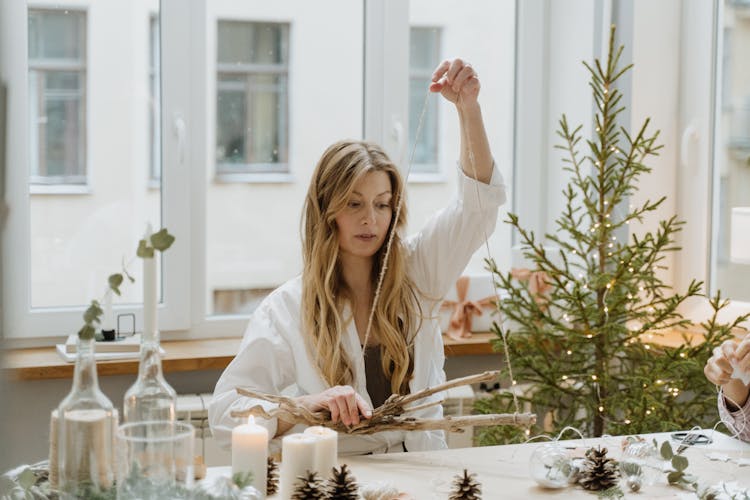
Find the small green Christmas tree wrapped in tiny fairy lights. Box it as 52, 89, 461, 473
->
475, 27, 749, 445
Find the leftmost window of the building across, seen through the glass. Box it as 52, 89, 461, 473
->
28, 9, 86, 184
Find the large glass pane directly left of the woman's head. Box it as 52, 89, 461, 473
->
205, 0, 364, 315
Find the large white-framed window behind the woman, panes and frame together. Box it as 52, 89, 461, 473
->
0, 0, 516, 342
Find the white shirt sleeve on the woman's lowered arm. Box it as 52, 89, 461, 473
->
208, 295, 296, 446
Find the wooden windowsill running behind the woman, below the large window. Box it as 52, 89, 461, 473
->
2, 332, 502, 380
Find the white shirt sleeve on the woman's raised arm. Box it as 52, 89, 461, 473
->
406, 164, 506, 299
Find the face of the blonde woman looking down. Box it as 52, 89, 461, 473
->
336, 171, 393, 258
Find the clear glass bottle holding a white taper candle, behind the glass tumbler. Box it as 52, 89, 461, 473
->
123, 331, 177, 423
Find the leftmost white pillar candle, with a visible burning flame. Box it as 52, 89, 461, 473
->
232, 416, 268, 497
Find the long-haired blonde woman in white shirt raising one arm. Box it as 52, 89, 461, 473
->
209, 59, 505, 454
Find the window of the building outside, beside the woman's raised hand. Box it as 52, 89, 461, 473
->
409, 28, 440, 172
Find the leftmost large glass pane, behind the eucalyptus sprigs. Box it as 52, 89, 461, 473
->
28, 4, 161, 308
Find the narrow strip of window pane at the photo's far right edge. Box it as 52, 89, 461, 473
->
714, 2, 750, 302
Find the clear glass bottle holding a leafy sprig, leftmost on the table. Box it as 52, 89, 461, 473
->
52, 338, 117, 499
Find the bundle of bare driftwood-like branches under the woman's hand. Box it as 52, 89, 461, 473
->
231, 371, 536, 434
